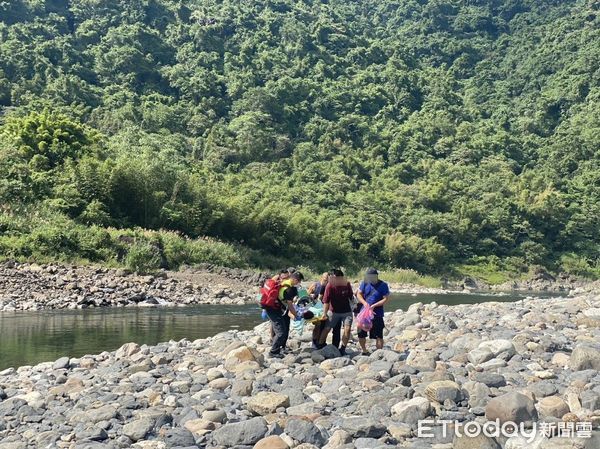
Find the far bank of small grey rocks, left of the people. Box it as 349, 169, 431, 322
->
0, 262, 260, 312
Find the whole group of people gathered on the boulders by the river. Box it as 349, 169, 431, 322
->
263, 268, 390, 358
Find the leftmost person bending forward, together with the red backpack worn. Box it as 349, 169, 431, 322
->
260, 271, 304, 358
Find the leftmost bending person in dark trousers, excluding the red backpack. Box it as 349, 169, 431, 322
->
267, 271, 304, 358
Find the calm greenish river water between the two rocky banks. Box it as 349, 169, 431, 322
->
0, 293, 560, 370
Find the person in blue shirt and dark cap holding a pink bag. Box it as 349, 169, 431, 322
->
356, 268, 390, 355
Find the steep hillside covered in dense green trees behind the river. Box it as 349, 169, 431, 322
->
0, 0, 600, 276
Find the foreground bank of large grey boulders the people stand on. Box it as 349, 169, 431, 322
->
0, 294, 600, 449
